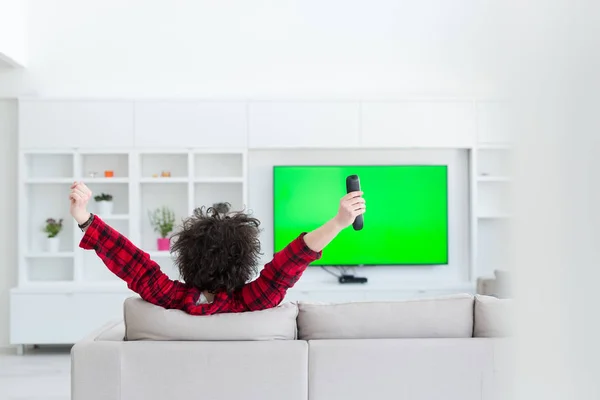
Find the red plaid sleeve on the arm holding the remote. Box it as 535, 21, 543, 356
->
238, 233, 322, 311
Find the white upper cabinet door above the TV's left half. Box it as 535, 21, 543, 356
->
248, 102, 360, 148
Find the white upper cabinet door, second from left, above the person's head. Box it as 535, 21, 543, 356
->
135, 101, 248, 148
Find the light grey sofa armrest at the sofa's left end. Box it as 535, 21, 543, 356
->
71, 321, 123, 400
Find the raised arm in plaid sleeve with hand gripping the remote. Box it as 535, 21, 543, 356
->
238, 192, 366, 311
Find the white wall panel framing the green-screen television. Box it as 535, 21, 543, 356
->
248, 150, 469, 288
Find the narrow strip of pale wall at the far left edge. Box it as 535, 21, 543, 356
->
0, 100, 17, 348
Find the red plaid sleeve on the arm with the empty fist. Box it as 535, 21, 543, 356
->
79, 216, 187, 308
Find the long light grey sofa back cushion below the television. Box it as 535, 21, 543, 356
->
298, 294, 473, 340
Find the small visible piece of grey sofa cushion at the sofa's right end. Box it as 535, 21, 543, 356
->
473, 294, 513, 337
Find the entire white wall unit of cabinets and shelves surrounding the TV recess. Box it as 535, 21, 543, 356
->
10, 98, 513, 350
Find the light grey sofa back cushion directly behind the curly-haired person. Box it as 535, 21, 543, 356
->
124, 297, 298, 341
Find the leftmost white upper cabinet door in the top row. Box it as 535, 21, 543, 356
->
19, 100, 133, 149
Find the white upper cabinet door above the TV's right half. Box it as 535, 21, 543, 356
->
361, 101, 476, 148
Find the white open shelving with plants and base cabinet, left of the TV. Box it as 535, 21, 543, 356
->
11, 148, 248, 345
